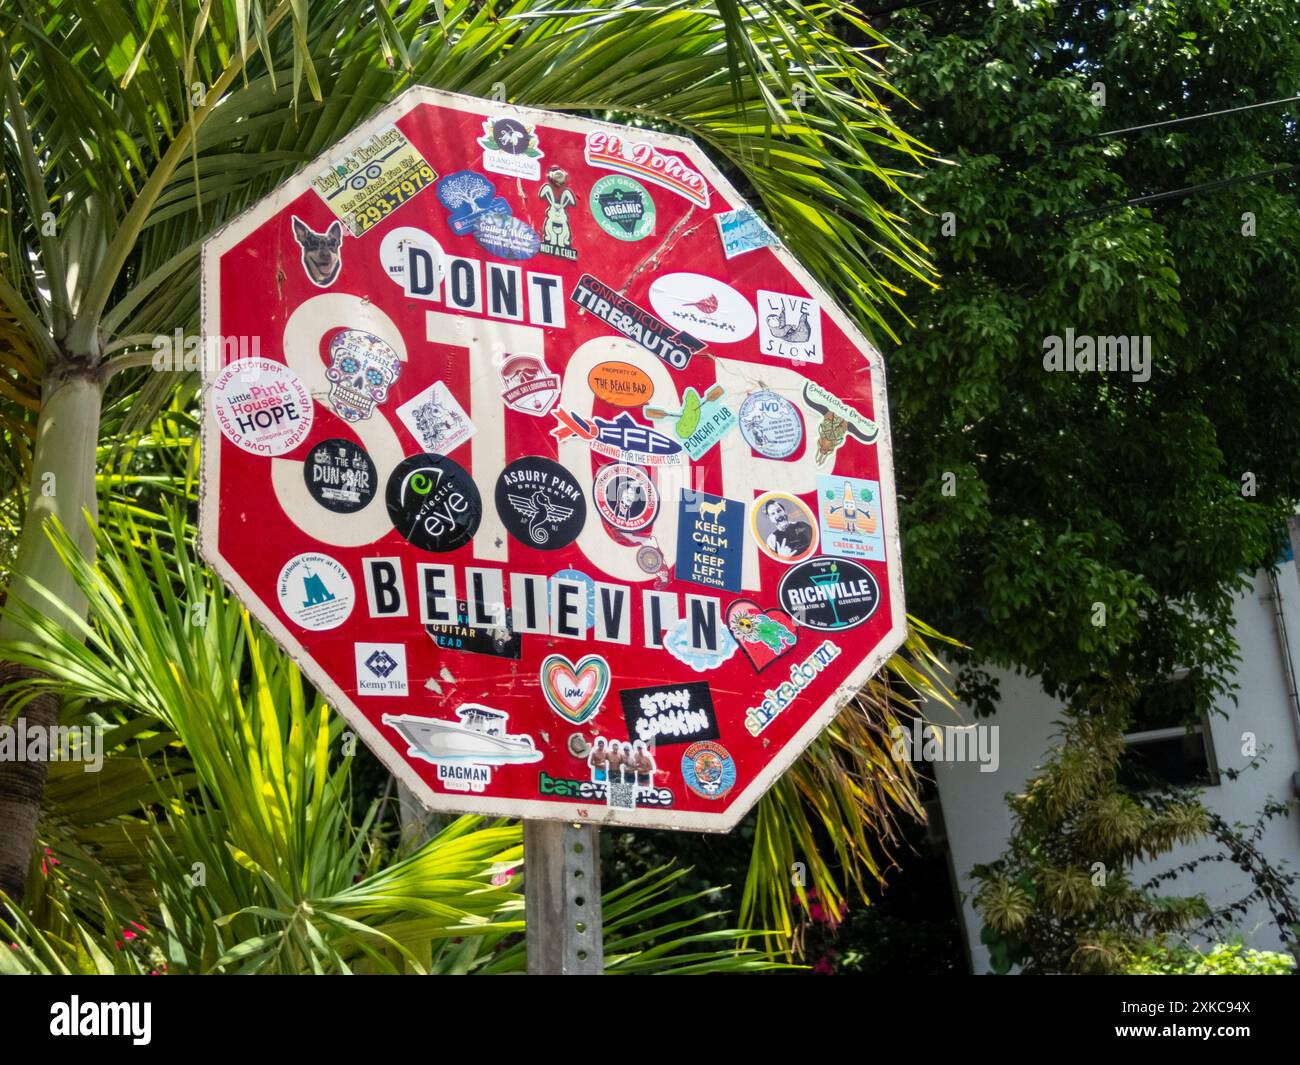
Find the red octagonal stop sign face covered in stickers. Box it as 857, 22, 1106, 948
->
202, 90, 905, 830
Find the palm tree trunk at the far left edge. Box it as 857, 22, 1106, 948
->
0, 364, 101, 901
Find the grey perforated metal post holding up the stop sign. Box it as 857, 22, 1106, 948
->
524, 821, 605, 977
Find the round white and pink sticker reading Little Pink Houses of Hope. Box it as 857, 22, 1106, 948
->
208, 359, 315, 455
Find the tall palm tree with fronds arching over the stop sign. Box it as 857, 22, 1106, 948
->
0, 0, 930, 897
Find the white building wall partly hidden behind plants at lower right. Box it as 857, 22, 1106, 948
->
931, 559, 1300, 973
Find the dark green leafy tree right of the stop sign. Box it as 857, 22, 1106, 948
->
887, 0, 1300, 710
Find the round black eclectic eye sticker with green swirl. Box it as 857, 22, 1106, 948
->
386, 454, 484, 551
